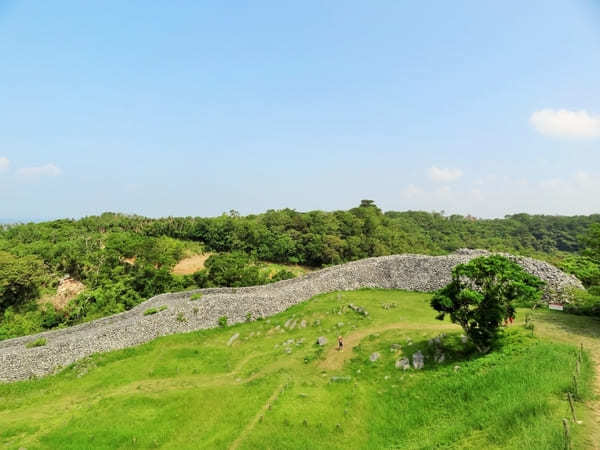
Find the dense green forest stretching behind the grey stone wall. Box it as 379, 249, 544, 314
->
0, 200, 600, 339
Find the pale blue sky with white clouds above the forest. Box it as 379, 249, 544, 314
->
0, 0, 600, 219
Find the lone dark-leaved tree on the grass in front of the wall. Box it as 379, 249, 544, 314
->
431, 255, 544, 353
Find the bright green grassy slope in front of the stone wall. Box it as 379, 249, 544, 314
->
0, 290, 600, 449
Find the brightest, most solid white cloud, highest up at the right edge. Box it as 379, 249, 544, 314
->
529, 109, 600, 139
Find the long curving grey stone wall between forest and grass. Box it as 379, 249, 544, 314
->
0, 250, 582, 382
